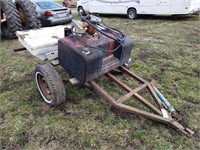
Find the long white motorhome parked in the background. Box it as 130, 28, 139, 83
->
77, 0, 200, 19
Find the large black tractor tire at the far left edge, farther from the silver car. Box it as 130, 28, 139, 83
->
0, 0, 22, 39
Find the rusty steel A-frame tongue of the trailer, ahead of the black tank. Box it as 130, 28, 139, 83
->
90, 67, 194, 137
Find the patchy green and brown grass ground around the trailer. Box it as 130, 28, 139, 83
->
0, 12, 200, 150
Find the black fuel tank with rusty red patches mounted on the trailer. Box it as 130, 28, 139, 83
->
58, 34, 133, 83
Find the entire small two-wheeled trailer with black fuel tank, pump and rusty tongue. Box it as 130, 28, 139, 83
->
15, 15, 195, 137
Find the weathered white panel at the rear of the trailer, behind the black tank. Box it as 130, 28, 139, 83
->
16, 25, 71, 60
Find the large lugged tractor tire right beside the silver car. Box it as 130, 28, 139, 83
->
15, 0, 41, 30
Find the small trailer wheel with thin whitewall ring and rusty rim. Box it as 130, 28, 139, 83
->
35, 64, 66, 106
